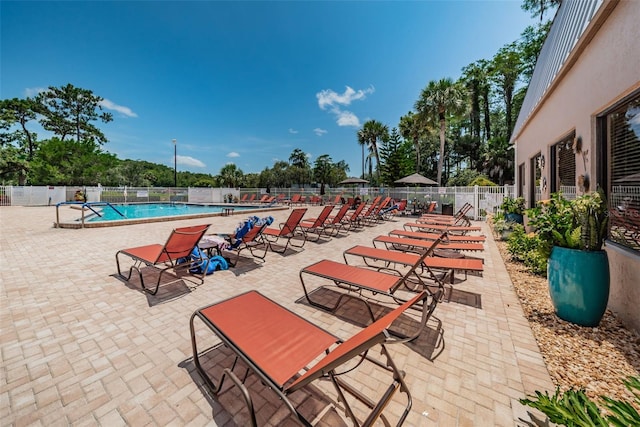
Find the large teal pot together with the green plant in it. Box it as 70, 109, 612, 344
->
527, 189, 609, 326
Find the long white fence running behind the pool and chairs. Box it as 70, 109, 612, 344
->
0, 185, 524, 220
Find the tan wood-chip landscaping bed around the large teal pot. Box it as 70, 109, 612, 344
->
496, 240, 640, 411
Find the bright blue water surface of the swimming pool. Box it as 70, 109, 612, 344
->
85, 203, 256, 222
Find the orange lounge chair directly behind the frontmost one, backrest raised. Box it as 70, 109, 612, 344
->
299, 233, 446, 318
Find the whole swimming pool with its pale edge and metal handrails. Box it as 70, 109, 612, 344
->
54, 202, 282, 228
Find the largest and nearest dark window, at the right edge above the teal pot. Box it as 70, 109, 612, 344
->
598, 91, 640, 251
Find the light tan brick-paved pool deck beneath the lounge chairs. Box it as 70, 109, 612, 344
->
0, 207, 555, 426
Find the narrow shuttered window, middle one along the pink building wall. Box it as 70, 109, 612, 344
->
549, 132, 576, 199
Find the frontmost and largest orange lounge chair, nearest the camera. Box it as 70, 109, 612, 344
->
189, 291, 430, 426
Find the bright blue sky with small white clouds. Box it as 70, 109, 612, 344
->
0, 0, 536, 176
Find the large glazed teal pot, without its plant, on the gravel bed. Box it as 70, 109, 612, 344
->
547, 246, 609, 326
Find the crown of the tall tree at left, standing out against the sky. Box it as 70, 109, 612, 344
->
36, 84, 113, 144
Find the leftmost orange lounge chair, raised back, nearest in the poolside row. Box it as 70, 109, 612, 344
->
116, 224, 209, 295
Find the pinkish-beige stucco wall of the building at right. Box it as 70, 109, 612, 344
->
514, 0, 640, 332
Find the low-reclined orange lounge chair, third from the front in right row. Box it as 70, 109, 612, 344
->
342, 245, 484, 283
